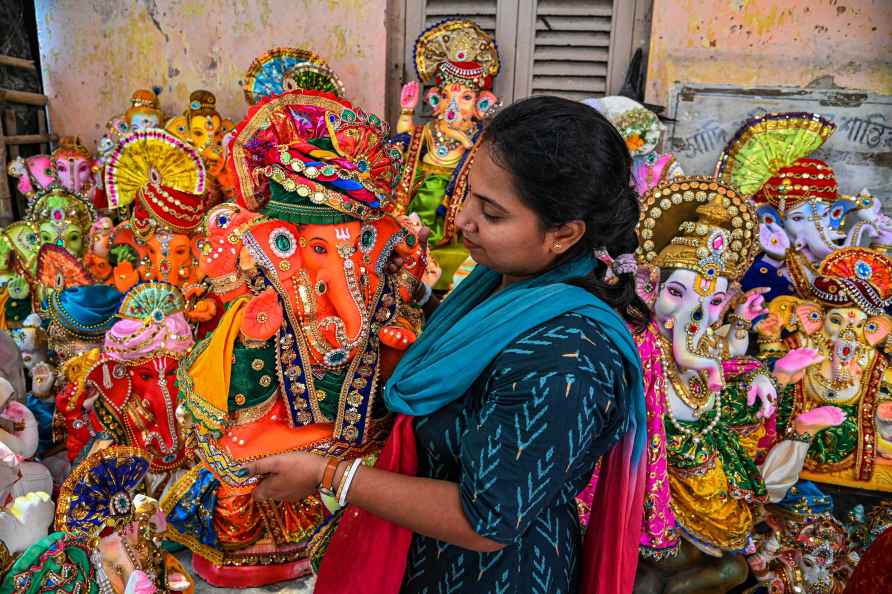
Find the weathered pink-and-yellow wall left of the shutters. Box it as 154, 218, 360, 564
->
35, 0, 387, 147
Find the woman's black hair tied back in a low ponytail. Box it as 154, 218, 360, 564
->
481, 97, 650, 330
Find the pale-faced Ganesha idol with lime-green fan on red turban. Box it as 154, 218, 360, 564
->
716, 113, 892, 301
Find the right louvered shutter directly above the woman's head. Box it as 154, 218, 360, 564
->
514, 0, 635, 99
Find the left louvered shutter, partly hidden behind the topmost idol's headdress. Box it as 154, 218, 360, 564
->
405, 0, 517, 104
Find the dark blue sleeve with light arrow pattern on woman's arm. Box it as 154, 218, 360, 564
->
459, 316, 626, 544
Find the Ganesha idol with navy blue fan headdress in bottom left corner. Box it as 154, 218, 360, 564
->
0, 447, 194, 594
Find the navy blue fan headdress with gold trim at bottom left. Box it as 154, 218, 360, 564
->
56, 446, 149, 537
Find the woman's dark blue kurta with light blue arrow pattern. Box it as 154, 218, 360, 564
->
402, 314, 627, 594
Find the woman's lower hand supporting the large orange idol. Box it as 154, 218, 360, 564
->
245, 452, 326, 503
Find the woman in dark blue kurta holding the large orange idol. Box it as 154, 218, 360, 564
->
248, 97, 647, 592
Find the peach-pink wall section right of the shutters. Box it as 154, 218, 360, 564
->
647, 0, 892, 105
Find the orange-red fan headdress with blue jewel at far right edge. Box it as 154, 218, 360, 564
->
810, 247, 892, 316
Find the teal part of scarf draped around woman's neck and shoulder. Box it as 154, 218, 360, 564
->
384, 257, 647, 464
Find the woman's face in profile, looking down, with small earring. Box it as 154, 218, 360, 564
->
456, 145, 584, 280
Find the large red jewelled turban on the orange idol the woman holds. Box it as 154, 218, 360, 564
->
229, 91, 400, 223
